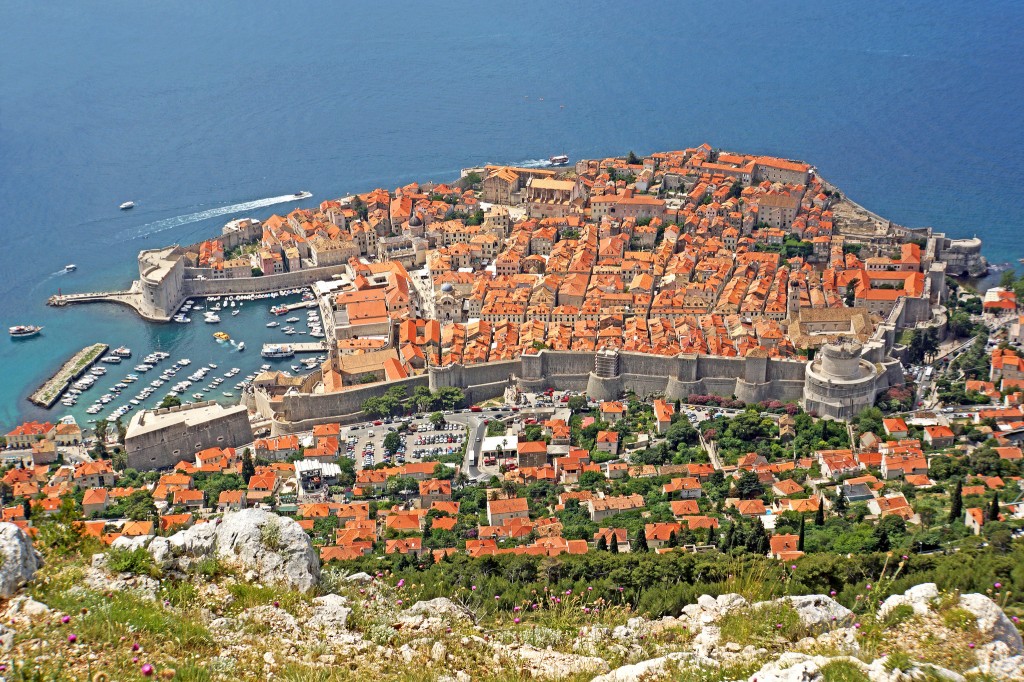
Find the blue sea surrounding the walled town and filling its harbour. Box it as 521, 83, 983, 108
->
0, 0, 1024, 430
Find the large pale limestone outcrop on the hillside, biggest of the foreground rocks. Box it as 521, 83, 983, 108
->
141, 509, 319, 592
